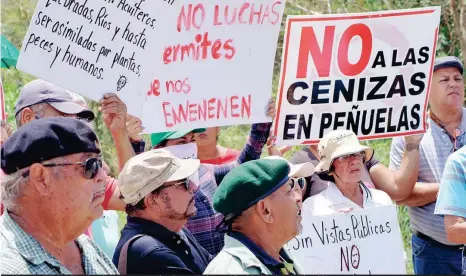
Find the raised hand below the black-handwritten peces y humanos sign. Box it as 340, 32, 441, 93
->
99, 93, 127, 134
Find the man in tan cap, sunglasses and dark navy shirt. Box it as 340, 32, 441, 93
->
113, 149, 211, 275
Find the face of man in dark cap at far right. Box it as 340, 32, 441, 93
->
429, 67, 464, 110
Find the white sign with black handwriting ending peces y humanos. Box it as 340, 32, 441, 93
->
16, 0, 176, 117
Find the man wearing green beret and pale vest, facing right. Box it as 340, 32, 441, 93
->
204, 159, 302, 275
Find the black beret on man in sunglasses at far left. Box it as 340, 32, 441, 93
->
1, 117, 100, 174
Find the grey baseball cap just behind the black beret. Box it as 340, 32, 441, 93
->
15, 79, 95, 121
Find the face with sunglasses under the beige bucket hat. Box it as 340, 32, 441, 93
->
333, 151, 365, 183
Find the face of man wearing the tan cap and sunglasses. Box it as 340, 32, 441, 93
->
154, 179, 197, 220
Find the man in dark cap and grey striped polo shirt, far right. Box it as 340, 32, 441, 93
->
390, 57, 466, 275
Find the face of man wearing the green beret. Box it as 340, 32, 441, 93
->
270, 179, 302, 240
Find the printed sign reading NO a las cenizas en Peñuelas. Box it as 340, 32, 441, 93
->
273, 7, 440, 145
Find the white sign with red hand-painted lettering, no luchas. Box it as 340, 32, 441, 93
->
143, 0, 285, 132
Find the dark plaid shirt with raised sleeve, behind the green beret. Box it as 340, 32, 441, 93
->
186, 123, 272, 256
